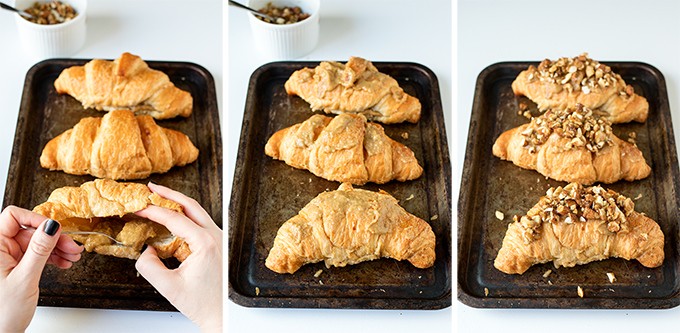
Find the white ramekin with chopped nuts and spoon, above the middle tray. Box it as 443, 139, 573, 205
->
248, 0, 321, 60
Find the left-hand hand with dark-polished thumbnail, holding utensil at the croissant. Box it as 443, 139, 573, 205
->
0, 206, 83, 332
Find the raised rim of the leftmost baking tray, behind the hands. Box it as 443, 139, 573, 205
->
2, 58, 223, 311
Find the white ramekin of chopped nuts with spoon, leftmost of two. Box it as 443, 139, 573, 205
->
14, 0, 87, 59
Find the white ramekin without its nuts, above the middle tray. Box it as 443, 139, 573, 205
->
248, 0, 321, 60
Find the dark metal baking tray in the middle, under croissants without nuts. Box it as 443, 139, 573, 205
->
229, 62, 451, 309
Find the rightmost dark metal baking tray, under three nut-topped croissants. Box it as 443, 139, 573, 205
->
458, 62, 680, 309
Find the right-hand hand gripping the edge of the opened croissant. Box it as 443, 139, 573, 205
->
135, 183, 222, 332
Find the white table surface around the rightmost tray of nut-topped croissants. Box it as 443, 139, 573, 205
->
451, 0, 680, 333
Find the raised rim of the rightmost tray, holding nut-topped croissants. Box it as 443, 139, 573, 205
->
457, 61, 680, 309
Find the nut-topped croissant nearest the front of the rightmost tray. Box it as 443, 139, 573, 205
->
494, 183, 664, 274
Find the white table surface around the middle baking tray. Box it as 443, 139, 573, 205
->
223, 0, 452, 333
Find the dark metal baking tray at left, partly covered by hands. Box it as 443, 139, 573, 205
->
3, 59, 222, 311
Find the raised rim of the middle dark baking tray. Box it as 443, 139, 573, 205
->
227, 61, 453, 310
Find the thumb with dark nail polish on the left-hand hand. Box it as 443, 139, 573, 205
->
12, 219, 61, 285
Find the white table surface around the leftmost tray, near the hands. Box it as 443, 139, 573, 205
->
0, 0, 223, 333
